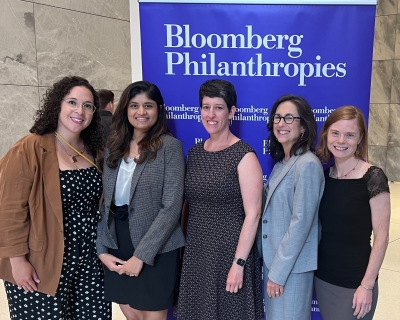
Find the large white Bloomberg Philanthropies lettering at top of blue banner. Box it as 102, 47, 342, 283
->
165, 24, 346, 86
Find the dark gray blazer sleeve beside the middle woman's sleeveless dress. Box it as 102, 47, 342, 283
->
134, 139, 185, 265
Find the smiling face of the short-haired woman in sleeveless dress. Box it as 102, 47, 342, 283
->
201, 97, 236, 134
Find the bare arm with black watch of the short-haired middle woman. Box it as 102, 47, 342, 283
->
226, 152, 263, 292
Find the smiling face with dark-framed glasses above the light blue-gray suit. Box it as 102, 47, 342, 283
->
274, 101, 304, 154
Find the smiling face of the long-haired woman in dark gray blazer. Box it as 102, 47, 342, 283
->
128, 93, 158, 134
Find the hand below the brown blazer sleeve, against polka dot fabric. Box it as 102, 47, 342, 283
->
10, 256, 40, 292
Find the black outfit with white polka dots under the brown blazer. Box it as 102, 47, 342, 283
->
5, 167, 111, 320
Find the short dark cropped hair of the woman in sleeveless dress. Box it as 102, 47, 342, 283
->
199, 79, 237, 112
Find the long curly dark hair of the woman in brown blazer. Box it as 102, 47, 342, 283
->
29, 76, 103, 154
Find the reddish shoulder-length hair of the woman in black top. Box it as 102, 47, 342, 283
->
317, 106, 368, 163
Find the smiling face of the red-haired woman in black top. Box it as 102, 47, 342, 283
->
327, 119, 362, 160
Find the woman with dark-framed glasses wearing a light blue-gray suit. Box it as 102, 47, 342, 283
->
259, 95, 325, 320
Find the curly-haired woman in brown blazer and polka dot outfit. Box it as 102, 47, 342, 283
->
0, 77, 111, 320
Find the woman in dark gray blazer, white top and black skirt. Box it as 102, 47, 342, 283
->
97, 81, 185, 320
